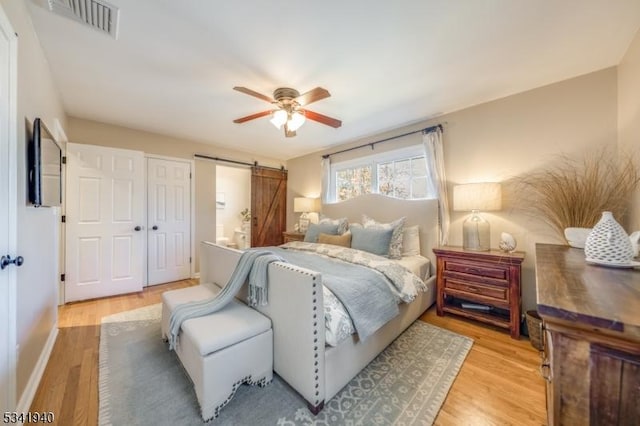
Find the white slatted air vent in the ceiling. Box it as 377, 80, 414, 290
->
49, 0, 120, 38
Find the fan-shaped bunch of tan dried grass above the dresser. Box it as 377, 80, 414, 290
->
519, 149, 640, 243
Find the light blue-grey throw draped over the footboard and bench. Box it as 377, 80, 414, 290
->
168, 249, 285, 349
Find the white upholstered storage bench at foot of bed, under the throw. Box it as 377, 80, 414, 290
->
163, 286, 273, 421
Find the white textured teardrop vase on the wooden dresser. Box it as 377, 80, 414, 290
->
584, 212, 633, 266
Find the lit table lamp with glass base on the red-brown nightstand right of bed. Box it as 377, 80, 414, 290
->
453, 183, 502, 251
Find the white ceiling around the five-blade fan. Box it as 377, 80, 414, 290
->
28, 0, 640, 159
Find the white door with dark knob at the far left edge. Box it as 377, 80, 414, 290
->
0, 7, 17, 413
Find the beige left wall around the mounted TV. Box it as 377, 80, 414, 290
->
1, 0, 66, 409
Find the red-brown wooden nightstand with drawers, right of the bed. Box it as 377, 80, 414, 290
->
433, 246, 524, 339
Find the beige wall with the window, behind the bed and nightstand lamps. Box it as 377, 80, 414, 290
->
287, 68, 617, 309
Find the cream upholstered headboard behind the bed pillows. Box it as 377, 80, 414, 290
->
322, 194, 438, 271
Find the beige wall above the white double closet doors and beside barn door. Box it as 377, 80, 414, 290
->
67, 117, 284, 271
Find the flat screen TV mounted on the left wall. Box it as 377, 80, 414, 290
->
27, 118, 62, 207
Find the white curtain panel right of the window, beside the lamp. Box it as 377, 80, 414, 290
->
422, 126, 451, 245
